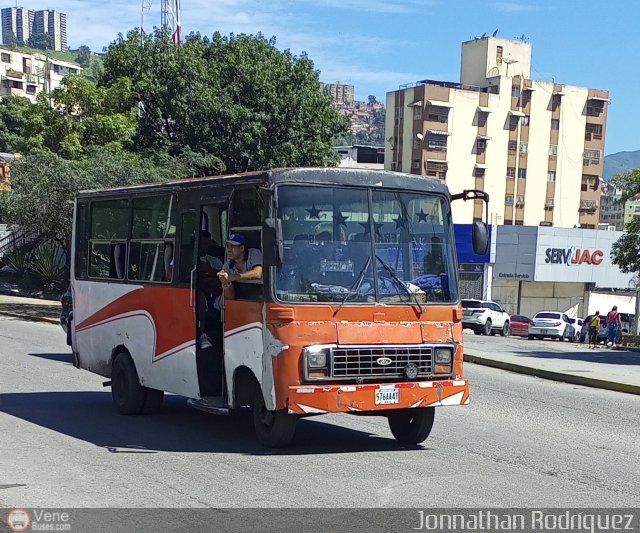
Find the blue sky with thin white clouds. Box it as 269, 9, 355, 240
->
22, 0, 640, 154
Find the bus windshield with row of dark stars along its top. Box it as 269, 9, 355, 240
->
275, 185, 458, 304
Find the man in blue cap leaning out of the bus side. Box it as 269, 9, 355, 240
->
218, 233, 262, 300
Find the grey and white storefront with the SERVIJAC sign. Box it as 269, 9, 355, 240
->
491, 226, 633, 317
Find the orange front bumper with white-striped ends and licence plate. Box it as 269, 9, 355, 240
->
288, 380, 469, 415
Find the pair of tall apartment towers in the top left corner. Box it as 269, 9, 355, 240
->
1, 7, 68, 50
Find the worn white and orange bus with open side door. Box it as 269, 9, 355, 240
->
70, 168, 488, 446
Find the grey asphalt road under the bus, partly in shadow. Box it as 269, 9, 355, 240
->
0, 318, 640, 508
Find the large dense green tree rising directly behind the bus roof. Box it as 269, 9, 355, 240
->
101, 32, 348, 173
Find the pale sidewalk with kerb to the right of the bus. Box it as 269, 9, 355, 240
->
464, 337, 640, 394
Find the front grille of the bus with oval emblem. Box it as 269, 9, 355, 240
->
331, 345, 433, 379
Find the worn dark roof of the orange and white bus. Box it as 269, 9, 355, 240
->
78, 167, 449, 197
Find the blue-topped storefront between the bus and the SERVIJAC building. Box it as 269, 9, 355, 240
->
453, 224, 491, 299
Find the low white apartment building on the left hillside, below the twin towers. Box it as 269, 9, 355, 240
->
0, 48, 82, 102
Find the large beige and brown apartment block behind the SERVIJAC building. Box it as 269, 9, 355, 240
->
385, 37, 609, 228
